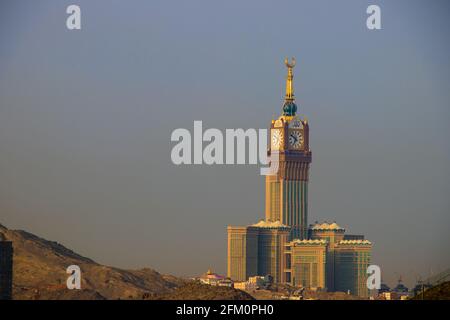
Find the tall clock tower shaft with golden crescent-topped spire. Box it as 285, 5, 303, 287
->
266, 58, 311, 239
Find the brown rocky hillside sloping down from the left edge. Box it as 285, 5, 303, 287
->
0, 224, 185, 300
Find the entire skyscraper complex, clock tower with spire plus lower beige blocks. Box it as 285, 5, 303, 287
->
227, 59, 372, 297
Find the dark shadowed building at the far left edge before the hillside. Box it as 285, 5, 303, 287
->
0, 233, 13, 300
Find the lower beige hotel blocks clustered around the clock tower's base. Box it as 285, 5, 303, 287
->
228, 220, 372, 297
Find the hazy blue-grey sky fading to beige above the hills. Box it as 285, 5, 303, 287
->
0, 0, 450, 285
